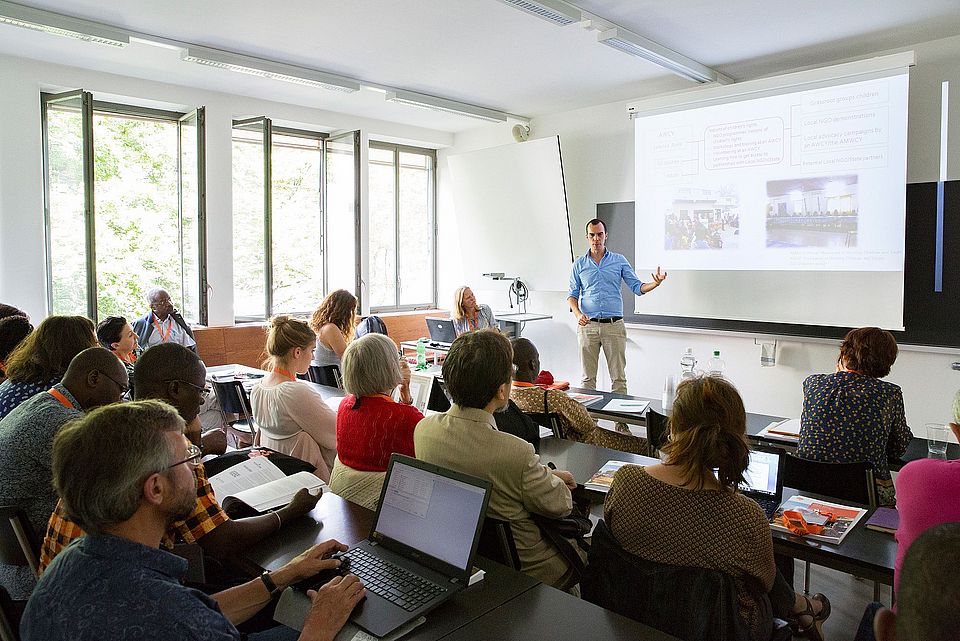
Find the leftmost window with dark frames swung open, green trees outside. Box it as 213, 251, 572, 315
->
42, 91, 206, 323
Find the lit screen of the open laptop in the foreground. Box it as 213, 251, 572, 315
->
374, 460, 486, 570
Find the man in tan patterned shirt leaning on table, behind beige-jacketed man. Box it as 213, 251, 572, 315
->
510, 338, 647, 454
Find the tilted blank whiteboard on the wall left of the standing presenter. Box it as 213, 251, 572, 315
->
449, 136, 573, 292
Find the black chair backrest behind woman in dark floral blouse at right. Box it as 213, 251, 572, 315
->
783, 453, 877, 507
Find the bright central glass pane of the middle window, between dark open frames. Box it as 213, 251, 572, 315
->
271, 133, 324, 314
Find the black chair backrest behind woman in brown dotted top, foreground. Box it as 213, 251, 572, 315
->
580, 520, 752, 641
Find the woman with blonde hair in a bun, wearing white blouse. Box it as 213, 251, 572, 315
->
250, 316, 337, 481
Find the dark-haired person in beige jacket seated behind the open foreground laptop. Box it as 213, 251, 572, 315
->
413, 329, 577, 590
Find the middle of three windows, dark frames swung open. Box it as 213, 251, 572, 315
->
233, 117, 359, 321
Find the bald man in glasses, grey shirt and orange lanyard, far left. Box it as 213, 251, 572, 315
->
0, 347, 127, 599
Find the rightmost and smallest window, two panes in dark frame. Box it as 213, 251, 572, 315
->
368, 142, 436, 311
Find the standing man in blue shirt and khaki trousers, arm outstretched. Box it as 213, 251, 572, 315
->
567, 218, 667, 402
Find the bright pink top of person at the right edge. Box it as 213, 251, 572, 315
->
893, 420, 960, 590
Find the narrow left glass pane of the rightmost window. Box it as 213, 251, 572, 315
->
368, 146, 397, 307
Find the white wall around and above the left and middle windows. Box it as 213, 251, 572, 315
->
0, 56, 453, 325
